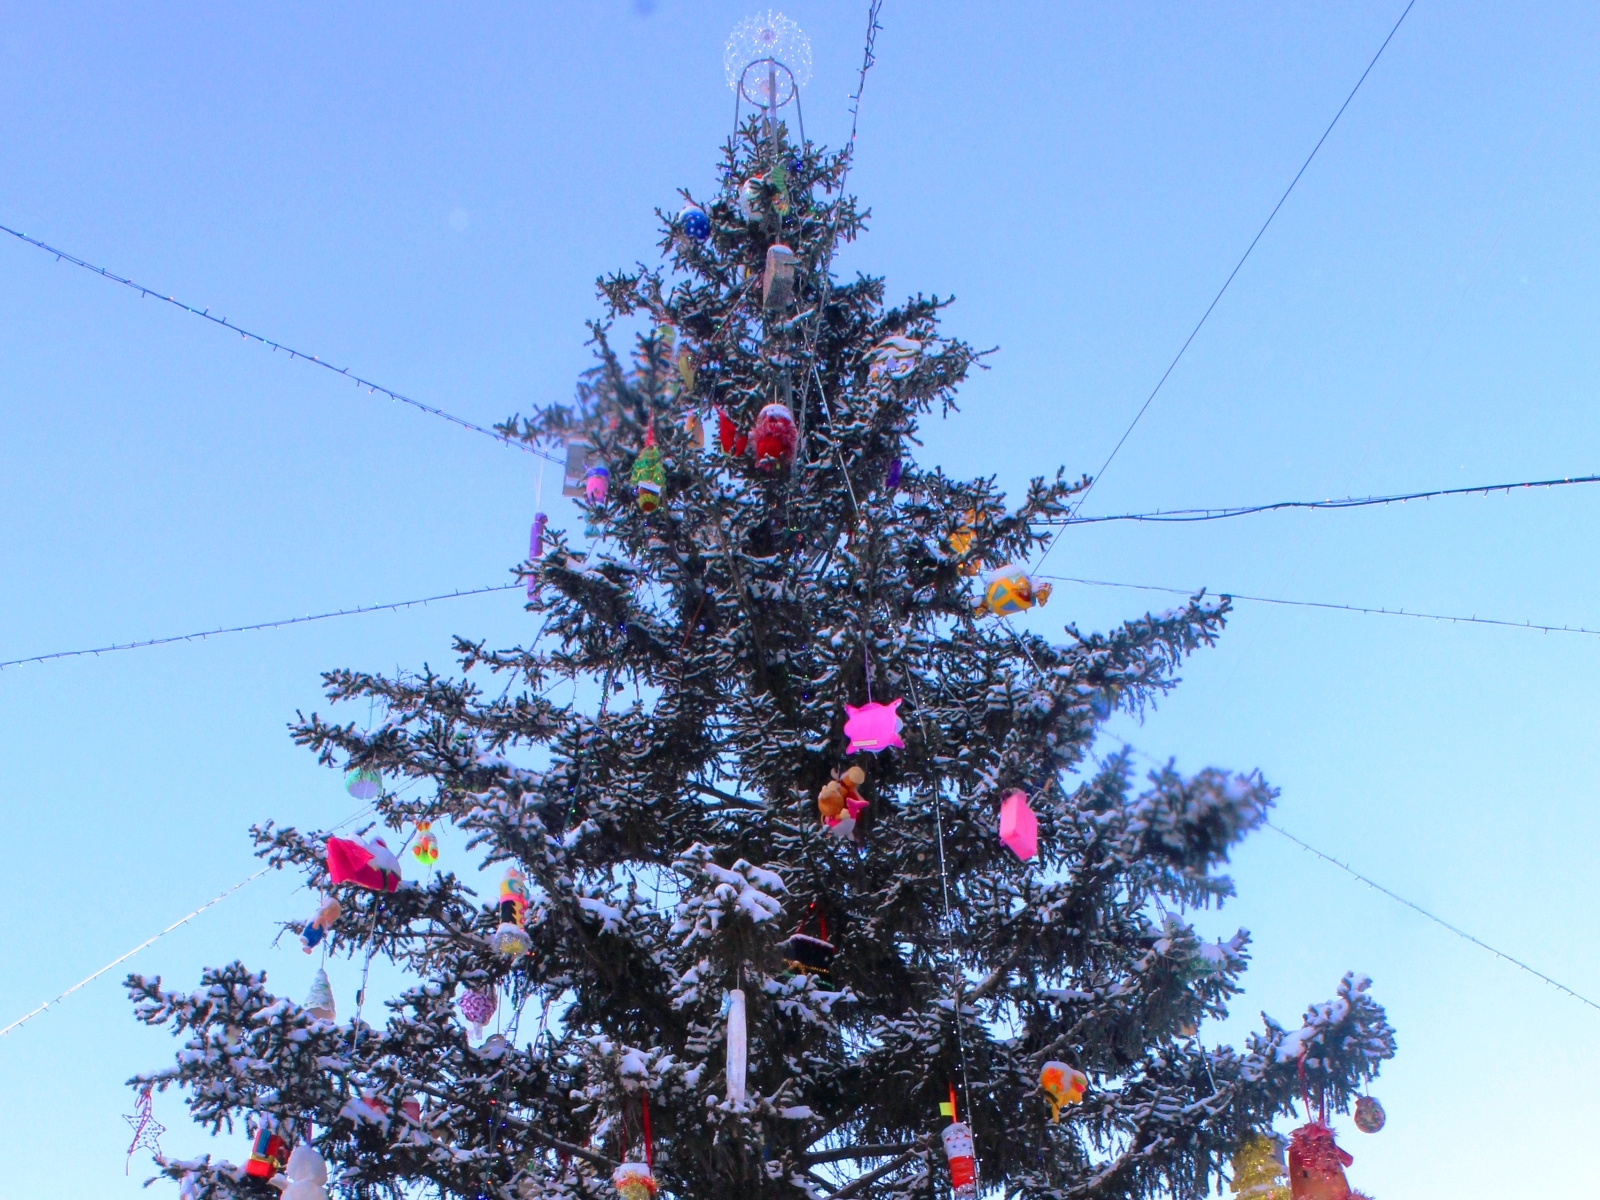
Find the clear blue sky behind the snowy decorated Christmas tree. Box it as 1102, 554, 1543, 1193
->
0, 0, 1600, 1200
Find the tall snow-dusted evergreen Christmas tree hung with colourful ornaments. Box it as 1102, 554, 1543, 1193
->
128, 18, 1394, 1200
